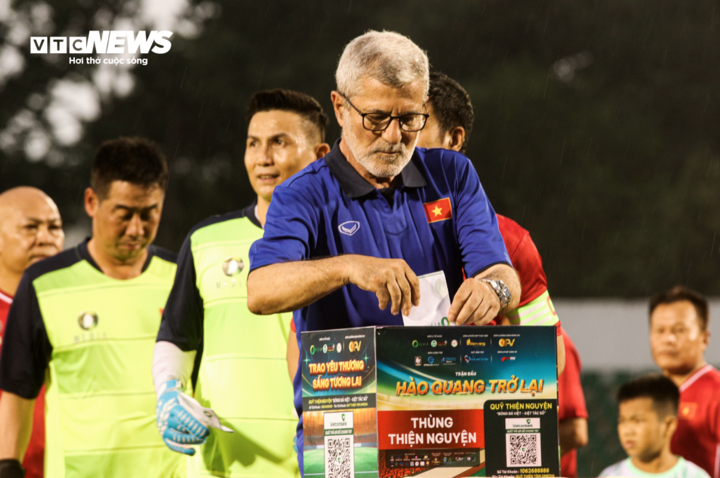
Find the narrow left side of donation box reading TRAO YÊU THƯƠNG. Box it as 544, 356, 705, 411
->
302, 327, 378, 478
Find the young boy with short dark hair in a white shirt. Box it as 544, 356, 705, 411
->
599, 374, 709, 478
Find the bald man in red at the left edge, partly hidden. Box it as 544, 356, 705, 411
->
0, 187, 65, 478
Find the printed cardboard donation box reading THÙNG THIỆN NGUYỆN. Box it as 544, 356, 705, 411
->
302, 326, 560, 478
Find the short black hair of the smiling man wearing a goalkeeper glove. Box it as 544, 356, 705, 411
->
247, 88, 328, 143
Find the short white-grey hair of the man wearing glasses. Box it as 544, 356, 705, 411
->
335, 30, 430, 97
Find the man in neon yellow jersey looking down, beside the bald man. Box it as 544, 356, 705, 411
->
0, 138, 185, 478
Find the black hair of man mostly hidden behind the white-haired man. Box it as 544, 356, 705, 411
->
428, 71, 475, 153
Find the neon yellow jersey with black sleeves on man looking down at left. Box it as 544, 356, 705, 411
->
0, 243, 185, 478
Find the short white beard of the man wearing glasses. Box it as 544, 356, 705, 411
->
343, 111, 415, 178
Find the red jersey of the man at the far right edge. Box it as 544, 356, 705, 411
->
670, 365, 720, 478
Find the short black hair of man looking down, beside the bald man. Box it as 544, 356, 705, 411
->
90, 138, 168, 199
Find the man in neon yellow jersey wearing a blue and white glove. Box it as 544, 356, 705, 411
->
153, 90, 330, 477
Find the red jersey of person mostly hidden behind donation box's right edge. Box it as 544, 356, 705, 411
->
558, 330, 588, 478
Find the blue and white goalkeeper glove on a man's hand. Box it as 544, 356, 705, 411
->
155, 380, 232, 456
